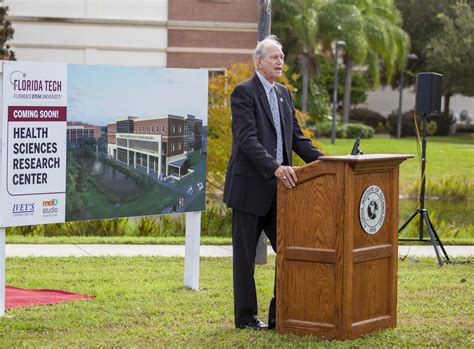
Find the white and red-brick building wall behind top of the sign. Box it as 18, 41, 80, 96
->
3, 0, 258, 69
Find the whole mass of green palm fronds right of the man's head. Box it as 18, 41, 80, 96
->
273, 0, 410, 123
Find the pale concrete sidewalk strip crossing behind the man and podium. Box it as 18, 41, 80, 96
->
6, 244, 474, 257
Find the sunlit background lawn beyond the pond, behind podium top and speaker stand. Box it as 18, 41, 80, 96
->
318, 135, 474, 196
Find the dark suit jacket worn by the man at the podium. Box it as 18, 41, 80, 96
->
224, 74, 322, 216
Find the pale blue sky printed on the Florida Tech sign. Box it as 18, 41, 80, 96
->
68, 64, 208, 126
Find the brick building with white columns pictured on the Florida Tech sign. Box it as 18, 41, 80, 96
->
107, 115, 202, 179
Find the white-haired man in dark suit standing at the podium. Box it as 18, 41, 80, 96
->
224, 35, 322, 329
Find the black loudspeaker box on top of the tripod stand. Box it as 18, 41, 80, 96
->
415, 73, 443, 114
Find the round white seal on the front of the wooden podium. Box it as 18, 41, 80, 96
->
359, 185, 385, 235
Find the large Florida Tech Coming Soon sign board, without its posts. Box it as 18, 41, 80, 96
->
0, 62, 207, 227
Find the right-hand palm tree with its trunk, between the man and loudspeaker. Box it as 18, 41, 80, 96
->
318, 0, 410, 122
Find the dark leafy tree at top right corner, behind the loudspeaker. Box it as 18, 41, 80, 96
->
426, 2, 474, 115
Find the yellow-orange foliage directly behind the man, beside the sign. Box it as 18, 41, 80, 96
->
207, 62, 313, 200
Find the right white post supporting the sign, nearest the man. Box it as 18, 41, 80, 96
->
184, 212, 201, 291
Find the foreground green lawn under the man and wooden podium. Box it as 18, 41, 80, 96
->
0, 257, 474, 348
